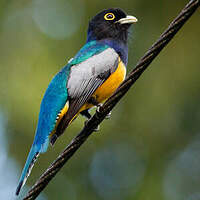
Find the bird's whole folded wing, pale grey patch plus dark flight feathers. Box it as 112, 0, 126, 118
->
51, 48, 119, 141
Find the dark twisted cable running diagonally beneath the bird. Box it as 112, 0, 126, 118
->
24, 0, 200, 200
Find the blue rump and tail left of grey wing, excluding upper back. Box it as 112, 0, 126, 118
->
16, 66, 69, 194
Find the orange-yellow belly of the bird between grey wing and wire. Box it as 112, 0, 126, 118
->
79, 59, 126, 113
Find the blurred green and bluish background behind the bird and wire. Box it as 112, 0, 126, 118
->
0, 0, 200, 200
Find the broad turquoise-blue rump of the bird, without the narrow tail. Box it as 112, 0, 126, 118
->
33, 65, 70, 152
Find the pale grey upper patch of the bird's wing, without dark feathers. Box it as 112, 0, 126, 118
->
67, 48, 119, 99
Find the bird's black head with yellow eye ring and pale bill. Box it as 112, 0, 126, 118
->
88, 8, 137, 43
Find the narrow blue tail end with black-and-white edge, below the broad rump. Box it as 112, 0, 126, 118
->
16, 144, 39, 195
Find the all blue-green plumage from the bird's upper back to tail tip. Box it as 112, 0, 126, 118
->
16, 41, 109, 194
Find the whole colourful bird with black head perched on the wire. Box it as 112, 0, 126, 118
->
16, 8, 137, 195
